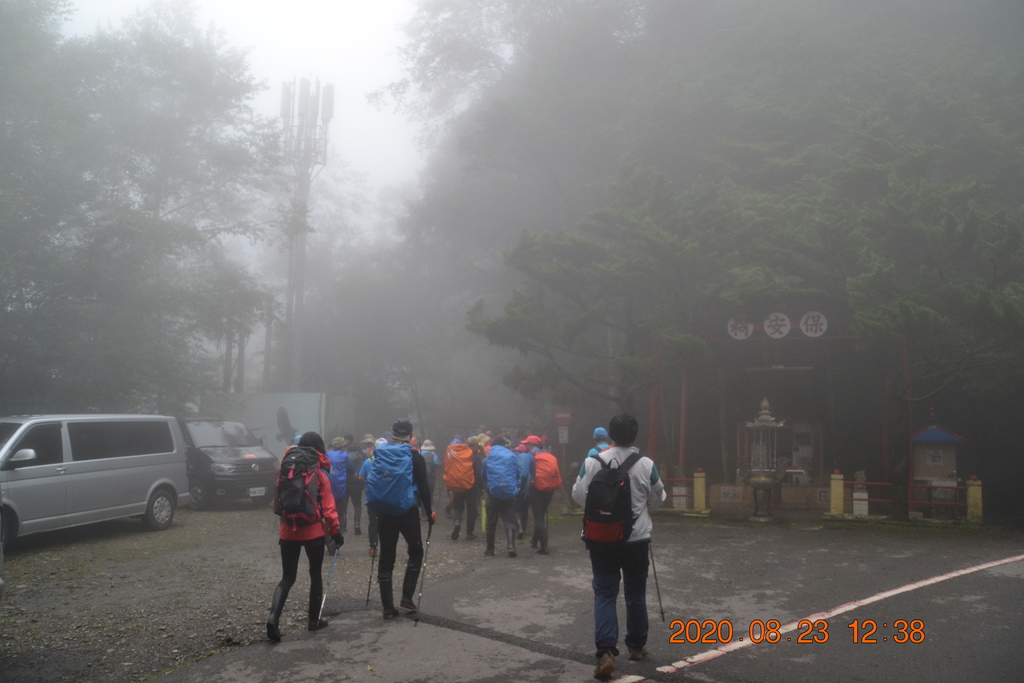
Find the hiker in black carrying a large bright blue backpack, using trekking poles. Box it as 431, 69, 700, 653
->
366, 420, 436, 620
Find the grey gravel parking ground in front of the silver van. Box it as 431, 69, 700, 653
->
0, 501, 477, 683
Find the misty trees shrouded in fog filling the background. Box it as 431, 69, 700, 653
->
0, 0, 1024, 518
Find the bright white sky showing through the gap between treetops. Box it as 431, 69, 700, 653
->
66, 0, 422, 200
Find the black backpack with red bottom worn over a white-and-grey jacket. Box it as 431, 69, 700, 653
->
583, 452, 640, 543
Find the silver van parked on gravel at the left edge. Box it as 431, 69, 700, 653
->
0, 415, 189, 544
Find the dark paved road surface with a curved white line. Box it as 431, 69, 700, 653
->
153, 515, 1024, 683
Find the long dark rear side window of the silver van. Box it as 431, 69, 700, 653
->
68, 420, 174, 462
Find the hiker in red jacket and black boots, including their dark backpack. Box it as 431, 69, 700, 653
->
266, 432, 345, 643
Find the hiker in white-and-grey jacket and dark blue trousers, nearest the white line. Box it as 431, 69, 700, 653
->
572, 414, 666, 680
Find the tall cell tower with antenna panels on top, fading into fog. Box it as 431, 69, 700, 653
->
281, 78, 334, 391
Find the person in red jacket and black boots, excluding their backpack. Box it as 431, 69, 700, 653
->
266, 431, 345, 643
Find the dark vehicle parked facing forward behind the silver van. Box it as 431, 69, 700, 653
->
180, 418, 280, 510
